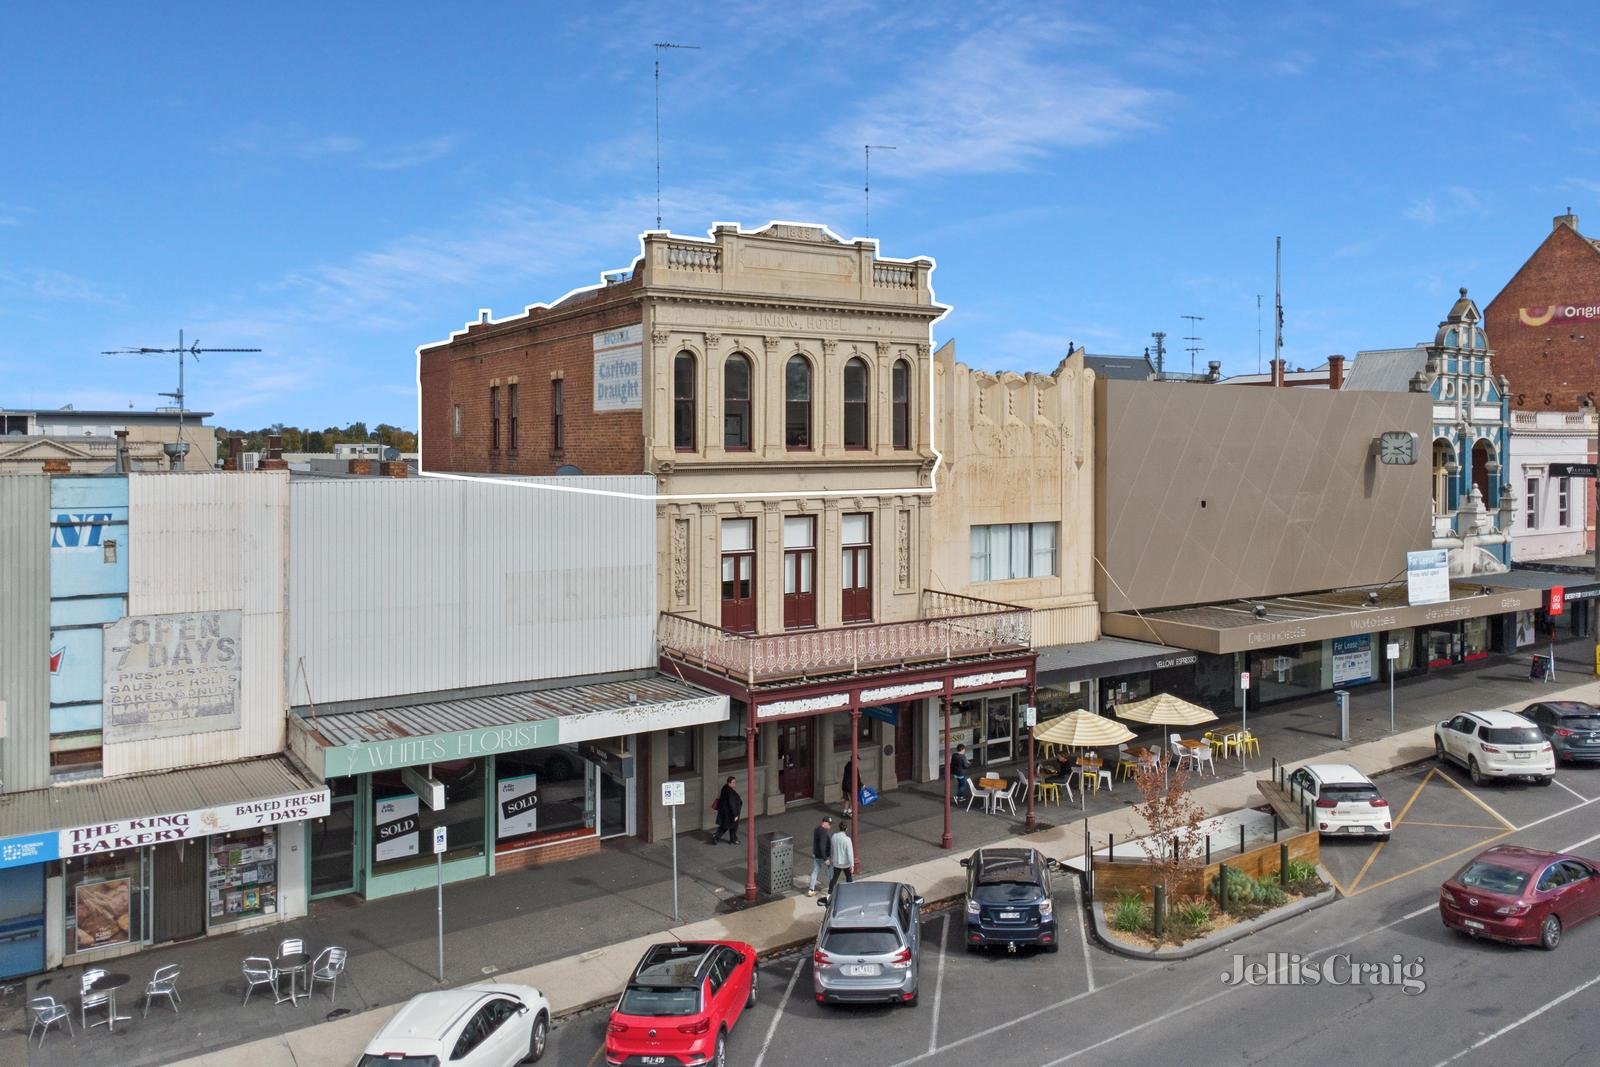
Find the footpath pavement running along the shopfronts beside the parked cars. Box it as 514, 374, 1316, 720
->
15, 640, 1600, 1067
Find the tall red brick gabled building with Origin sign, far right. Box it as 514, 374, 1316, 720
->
1483, 214, 1600, 411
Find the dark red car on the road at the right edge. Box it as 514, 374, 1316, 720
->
1438, 845, 1600, 949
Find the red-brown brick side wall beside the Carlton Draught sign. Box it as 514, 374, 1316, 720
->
419, 282, 650, 475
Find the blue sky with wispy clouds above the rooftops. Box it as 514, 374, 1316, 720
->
0, 0, 1600, 427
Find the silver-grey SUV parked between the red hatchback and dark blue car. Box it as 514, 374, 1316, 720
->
811, 881, 922, 1005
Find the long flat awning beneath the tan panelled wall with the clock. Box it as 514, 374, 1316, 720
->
1101, 574, 1544, 653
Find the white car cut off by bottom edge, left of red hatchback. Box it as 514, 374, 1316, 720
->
358, 984, 550, 1067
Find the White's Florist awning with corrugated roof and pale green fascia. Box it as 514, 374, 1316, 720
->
290, 675, 728, 779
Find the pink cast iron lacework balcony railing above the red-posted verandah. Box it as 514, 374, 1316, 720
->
656, 589, 1034, 686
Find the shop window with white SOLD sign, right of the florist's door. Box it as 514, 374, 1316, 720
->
493, 745, 598, 853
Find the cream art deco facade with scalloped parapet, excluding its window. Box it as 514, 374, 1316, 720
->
928, 342, 1099, 646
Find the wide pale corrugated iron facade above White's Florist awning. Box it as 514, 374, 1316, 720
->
288, 477, 656, 707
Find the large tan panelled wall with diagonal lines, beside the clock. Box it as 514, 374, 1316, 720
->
1094, 379, 1432, 611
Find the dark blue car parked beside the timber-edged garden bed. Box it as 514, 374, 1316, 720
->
962, 848, 1059, 952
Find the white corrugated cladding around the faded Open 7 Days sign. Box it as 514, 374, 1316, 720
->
120, 472, 290, 777
